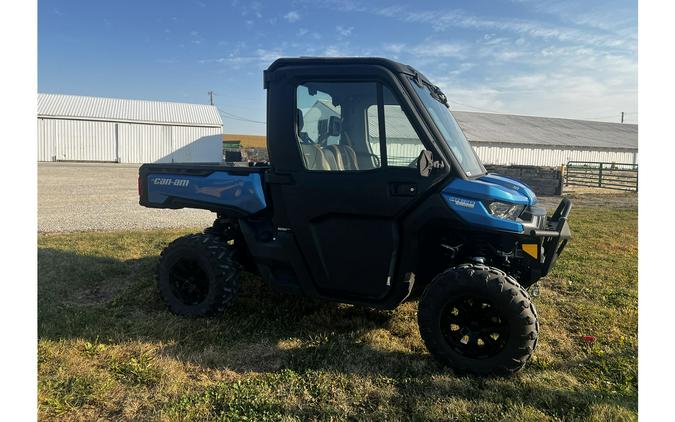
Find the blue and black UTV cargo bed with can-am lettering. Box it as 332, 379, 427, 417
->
138, 163, 268, 217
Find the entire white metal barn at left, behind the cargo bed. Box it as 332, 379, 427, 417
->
37, 94, 223, 163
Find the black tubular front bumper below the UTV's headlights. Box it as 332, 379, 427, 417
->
521, 198, 572, 278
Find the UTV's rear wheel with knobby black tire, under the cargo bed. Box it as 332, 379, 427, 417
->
157, 234, 240, 317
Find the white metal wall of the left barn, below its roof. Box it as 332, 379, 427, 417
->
38, 118, 222, 163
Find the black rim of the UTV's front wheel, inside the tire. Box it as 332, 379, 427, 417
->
441, 296, 509, 359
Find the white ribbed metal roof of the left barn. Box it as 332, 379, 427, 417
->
38, 94, 223, 127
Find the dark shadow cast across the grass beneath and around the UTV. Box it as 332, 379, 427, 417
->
38, 248, 636, 417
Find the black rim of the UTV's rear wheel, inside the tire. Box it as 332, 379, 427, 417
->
169, 258, 209, 305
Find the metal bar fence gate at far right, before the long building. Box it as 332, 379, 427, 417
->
565, 161, 638, 192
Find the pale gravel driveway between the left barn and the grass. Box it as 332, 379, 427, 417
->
38, 163, 215, 232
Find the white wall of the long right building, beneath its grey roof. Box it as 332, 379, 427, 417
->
472, 142, 638, 167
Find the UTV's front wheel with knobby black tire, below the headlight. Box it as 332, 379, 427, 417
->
418, 264, 539, 375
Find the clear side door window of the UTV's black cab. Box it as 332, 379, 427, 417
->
296, 82, 425, 171
